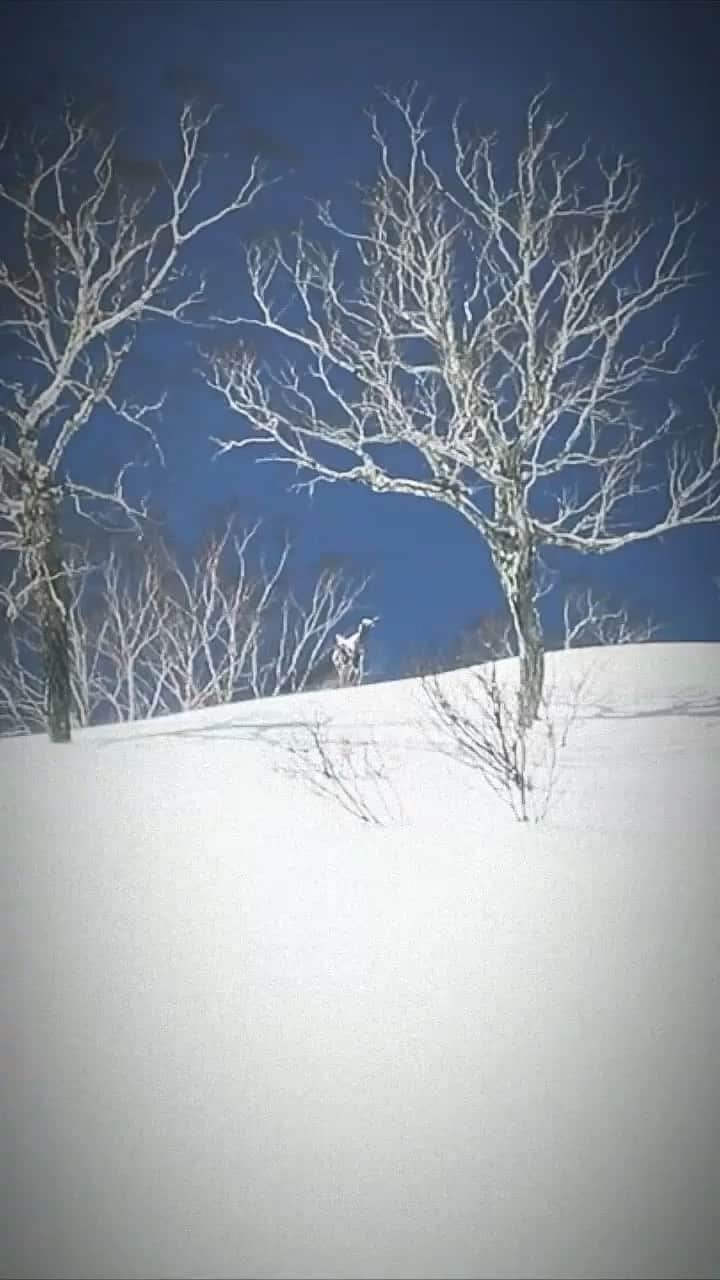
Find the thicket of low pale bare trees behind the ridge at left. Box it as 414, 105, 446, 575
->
0, 518, 368, 732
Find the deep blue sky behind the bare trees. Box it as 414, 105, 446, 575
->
0, 0, 720, 672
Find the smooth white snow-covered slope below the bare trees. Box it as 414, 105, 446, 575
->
0, 645, 720, 1280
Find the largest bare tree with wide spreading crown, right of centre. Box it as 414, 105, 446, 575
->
206, 91, 720, 723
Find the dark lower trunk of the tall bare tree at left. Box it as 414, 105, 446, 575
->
38, 539, 73, 742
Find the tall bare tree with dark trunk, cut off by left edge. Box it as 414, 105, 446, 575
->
0, 106, 269, 741
